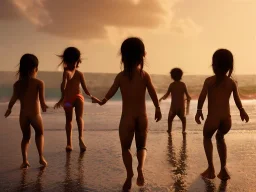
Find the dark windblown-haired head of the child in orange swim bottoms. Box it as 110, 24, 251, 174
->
59, 47, 81, 71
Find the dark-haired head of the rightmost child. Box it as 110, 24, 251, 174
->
212, 49, 234, 77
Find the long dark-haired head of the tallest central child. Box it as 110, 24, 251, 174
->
121, 37, 145, 78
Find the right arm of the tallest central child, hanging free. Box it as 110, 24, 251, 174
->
144, 72, 162, 122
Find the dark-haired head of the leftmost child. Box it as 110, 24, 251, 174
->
17, 53, 38, 79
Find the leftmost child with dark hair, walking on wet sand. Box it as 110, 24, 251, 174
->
5, 54, 48, 169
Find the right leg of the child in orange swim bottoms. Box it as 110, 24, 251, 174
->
75, 98, 86, 152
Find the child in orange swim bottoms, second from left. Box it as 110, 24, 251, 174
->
54, 47, 91, 152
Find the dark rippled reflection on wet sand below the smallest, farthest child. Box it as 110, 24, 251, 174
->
168, 134, 187, 192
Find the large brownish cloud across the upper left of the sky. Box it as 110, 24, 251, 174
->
0, 0, 166, 39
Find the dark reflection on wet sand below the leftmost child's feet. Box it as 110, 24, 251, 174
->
17, 167, 45, 192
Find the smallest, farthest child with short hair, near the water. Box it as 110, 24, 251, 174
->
159, 68, 191, 133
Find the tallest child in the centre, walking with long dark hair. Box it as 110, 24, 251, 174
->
92, 37, 162, 191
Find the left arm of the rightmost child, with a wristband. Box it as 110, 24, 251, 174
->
195, 79, 208, 124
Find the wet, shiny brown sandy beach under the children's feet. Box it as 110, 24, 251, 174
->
0, 100, 256, 192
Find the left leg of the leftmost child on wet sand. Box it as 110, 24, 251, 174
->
20, 115, 31, 169
